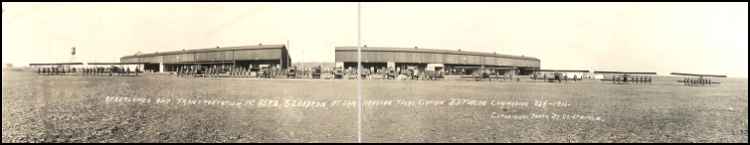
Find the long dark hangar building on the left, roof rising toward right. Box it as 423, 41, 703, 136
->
120, 44, 292, 72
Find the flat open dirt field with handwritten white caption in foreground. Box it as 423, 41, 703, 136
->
2, 72, 748, 143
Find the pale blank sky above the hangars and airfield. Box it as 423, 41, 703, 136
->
2, 2, 748, 78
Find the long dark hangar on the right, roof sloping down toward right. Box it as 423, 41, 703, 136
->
335, 46, 540, 75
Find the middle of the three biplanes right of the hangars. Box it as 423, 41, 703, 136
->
594, 71, 656, 84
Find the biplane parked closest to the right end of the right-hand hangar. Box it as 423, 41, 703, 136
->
530, 69, 590, 82
